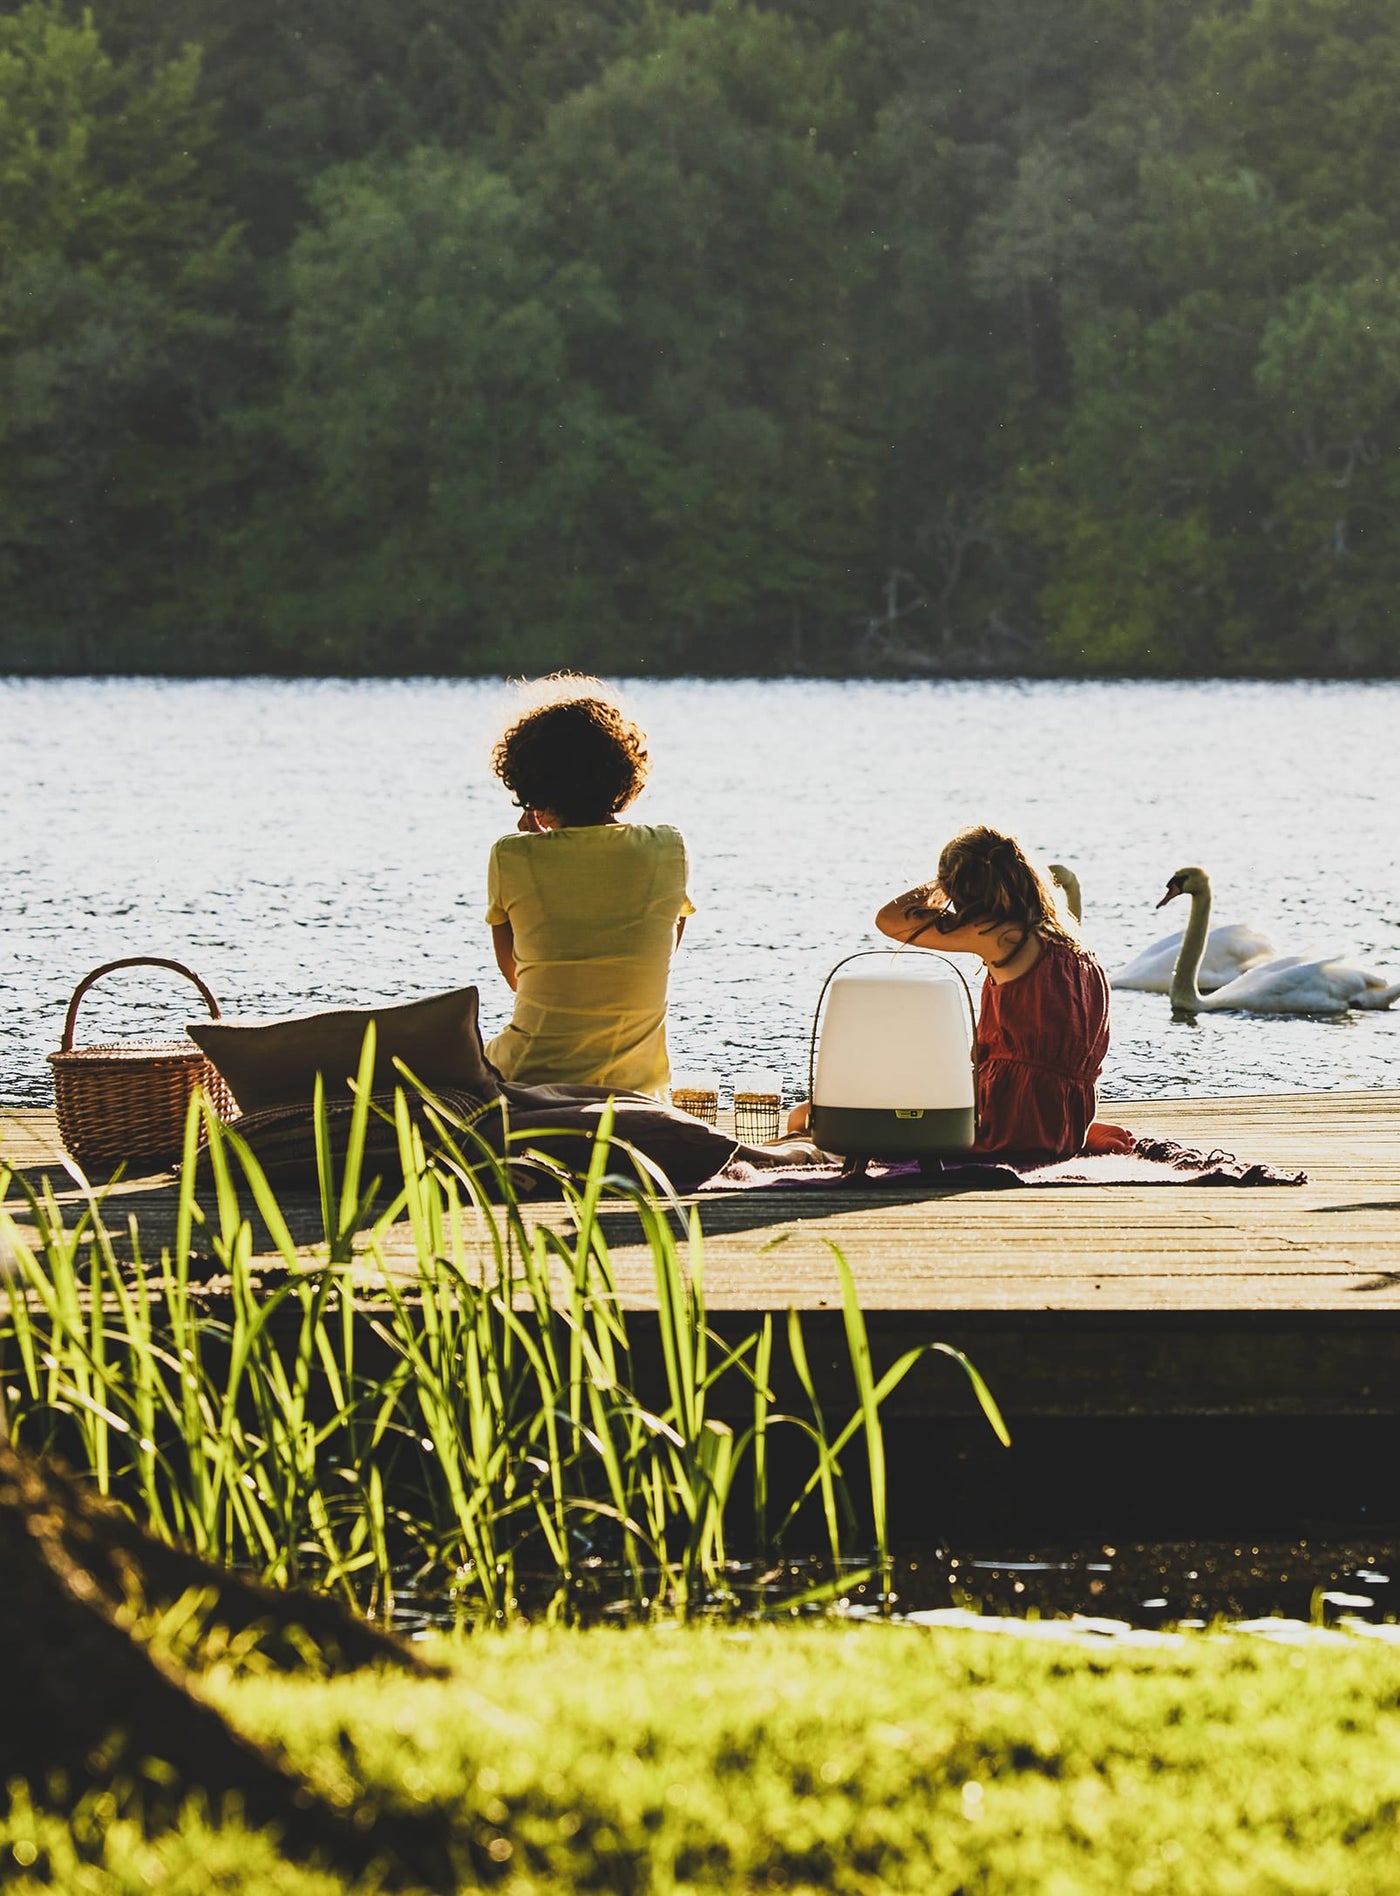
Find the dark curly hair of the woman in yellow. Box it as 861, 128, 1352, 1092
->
491, 677, 651, 825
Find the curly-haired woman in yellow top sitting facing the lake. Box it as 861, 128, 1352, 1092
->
486, 677, 694, 1096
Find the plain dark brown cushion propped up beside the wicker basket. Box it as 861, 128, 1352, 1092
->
188, 988, 501, 1113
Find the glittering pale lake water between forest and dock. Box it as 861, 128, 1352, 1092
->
0, 679, 1400, 1103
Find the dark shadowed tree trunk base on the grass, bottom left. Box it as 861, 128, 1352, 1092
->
0, 1433, 451, 1888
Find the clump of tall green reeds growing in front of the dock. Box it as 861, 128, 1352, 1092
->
0, 1031, 1007, 1619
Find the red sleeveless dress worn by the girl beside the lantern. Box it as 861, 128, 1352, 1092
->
977, 940, 1108, 1160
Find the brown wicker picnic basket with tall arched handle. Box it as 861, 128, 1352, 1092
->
49, 954, 235, 1166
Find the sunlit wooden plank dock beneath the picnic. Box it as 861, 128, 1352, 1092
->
0, 1090, 1400, 1426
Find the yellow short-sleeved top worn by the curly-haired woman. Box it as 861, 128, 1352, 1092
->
486, 823, 694, 1094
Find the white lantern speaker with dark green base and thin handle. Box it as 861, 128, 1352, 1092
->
810, 948, 977, 1158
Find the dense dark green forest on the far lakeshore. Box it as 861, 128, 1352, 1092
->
0, 0, 1400, 675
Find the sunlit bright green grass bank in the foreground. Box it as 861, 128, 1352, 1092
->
0, 1625, 1400, 1896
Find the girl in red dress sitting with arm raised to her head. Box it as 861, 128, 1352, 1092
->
875, 825, 1133, 1162
